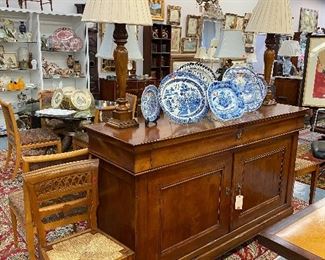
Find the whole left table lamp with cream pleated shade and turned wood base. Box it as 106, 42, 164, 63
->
82, 0, 152, 128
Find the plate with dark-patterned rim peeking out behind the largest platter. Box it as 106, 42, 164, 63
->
177, 62, 217, 89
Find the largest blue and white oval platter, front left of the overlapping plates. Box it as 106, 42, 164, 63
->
159, 71, 209, 124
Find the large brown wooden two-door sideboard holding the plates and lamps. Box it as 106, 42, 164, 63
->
87, 104, 307, 260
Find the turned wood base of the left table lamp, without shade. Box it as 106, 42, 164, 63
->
105, 24, 139, 128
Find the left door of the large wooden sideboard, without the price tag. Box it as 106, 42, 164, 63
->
148, 151, 232, 259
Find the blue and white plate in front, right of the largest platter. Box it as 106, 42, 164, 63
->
207, 81, 245, 121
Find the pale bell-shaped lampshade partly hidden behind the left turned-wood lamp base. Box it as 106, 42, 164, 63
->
96, 24, 143, 61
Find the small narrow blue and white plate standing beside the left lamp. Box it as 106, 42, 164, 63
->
141, 85, 160, 122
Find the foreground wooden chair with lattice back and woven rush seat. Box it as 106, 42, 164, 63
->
23, 160, 134, 260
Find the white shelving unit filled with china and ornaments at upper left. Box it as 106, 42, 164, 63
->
0, 8, 90, 129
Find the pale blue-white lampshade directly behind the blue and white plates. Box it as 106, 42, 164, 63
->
216, 30, 246, 59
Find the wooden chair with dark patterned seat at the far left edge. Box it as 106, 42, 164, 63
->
0, 99, 62, 178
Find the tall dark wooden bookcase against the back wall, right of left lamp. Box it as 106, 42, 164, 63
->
143, 24, 171, 81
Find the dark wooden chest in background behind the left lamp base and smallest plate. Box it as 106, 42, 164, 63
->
100, 78, 158, 100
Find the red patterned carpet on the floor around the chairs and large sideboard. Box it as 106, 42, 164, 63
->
0, 152, 307, 260
